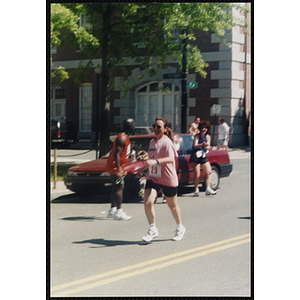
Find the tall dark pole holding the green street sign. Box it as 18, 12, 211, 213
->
181, 28, 188, 133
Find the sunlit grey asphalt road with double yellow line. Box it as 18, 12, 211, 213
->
50, 155, 251, 297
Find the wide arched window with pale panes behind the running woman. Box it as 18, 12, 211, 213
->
135, 82, 181, 132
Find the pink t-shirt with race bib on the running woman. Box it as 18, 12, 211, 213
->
147, 135, 178, 187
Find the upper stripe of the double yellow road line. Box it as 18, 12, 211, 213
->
51, 233, 250, 292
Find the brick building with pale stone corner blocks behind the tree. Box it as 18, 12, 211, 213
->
51, 4, 251, 147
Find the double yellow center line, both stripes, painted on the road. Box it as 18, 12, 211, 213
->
51, 234, 250, 296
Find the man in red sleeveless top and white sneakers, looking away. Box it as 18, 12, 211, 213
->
106, 119, 135, 221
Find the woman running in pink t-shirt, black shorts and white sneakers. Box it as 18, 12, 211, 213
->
138, 117, 186, 242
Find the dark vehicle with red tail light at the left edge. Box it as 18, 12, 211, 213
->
51, 119, 77, 148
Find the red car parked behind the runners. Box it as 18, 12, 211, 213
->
64, 134, 232, 200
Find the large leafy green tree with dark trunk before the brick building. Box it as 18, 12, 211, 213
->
51, 2, 246, 155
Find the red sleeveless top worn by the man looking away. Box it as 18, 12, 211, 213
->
106, 132, 131, 175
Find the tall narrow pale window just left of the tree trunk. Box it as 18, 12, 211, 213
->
79, 83, 93, 132
